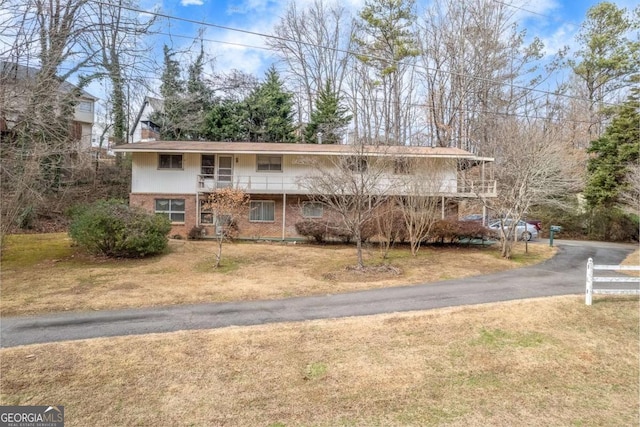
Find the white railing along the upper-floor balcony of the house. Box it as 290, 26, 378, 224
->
197, 175, 497, 197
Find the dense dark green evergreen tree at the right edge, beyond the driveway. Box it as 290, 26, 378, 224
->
584, 91, 640, 208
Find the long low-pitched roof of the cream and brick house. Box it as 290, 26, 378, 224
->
113, 141, 493, 161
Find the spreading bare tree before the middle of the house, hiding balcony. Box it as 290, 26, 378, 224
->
300, 144, 393, 269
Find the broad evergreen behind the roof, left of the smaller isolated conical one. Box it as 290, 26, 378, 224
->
246, 66, 295, 142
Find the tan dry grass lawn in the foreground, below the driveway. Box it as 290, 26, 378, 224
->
0, 296, 640, 427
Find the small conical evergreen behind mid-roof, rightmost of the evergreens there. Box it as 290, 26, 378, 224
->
305, 80, 352, 144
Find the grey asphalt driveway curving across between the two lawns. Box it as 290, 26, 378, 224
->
0, 240, 637, 347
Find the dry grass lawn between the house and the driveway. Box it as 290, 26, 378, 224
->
0, 234, 554, 316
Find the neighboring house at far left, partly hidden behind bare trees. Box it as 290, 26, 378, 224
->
0, 62, 98, 153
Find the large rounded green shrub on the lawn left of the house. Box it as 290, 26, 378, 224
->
69, 200, 171, 258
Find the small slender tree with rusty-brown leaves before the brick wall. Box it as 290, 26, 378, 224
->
202, 188, 249, 268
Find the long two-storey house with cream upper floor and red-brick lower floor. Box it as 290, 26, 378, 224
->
114, 141, 496, 240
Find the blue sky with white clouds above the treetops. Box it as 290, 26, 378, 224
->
143, 0, 637, 77
